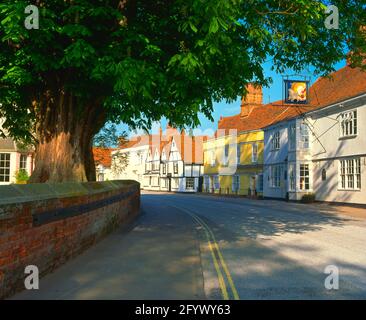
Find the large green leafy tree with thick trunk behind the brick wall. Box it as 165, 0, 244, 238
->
0, 0, 366, 182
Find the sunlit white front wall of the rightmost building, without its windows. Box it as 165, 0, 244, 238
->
312, 98, 366, 204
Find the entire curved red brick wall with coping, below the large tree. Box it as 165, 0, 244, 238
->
0, 181, 140, 299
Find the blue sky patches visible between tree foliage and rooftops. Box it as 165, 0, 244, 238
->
119, 61, 346, 137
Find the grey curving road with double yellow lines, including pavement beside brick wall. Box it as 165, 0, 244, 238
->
13, 193, 366, 299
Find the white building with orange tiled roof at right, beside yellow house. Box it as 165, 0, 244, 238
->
264, 66, 366, 204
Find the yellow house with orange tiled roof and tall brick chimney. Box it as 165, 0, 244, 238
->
203, 85, 283, 196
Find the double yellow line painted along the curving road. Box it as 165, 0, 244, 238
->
174, 208, 240, 300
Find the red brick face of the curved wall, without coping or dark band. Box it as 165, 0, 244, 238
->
0, 183, 140, 299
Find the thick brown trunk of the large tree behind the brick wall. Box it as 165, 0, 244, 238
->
29, 92, 105, 183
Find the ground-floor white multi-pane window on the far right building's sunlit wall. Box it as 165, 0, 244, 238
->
339, 158, 361, 190
